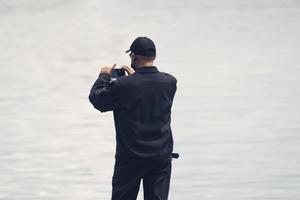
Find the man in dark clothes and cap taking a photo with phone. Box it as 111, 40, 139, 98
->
89, 37, 177, 200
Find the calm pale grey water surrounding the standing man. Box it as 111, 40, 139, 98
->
0, 0, 300, 200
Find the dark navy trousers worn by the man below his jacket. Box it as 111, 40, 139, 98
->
111, 159, 172, 200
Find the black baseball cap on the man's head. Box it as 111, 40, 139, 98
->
125, 37, 156, 57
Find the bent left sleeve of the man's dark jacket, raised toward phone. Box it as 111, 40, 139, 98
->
89, 73, 121, 112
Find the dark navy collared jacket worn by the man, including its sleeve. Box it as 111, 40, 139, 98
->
89, 66, 177, 163
